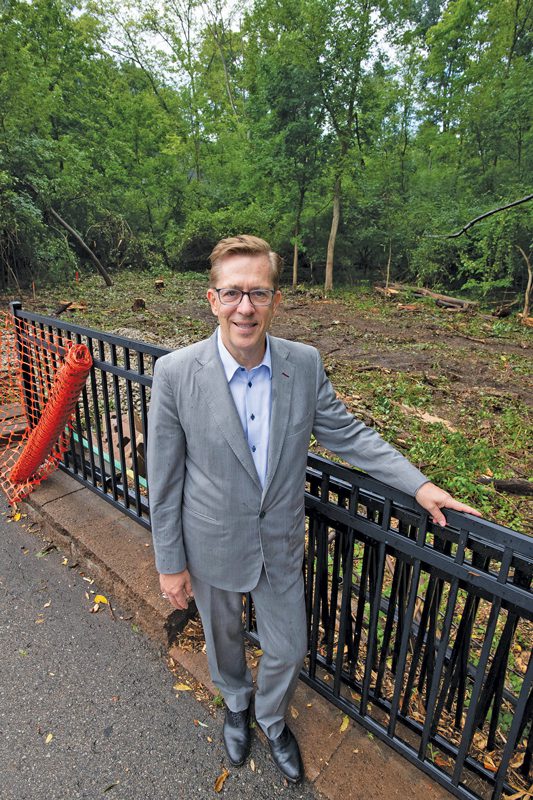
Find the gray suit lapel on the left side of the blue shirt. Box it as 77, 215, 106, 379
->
196, 333, 261, 489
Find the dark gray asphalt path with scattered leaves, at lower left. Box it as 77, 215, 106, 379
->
0, 502, 317, 800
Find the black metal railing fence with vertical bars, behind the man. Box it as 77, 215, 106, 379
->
12, 304, 533, 800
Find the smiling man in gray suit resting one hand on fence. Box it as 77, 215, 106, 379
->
148, 235, 477, 783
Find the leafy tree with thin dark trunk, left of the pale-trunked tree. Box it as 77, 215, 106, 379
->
245, 0, 324, 286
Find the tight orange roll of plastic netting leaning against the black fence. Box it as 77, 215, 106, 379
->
9, 344, 93, 484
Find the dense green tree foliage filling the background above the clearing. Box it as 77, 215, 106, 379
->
0, 0, 533, 296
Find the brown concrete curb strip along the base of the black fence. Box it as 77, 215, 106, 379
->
22, 471, 451, 800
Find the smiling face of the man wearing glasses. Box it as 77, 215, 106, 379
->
207, 255, 281, 369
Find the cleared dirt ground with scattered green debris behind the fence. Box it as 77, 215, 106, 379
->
4, 273, 533, 531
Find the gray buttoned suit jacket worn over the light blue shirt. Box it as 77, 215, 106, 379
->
147, 335, 427, 592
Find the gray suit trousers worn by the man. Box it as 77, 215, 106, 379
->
191, 569, 307, 739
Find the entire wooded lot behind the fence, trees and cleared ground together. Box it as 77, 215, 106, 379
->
0, 0, 533, 530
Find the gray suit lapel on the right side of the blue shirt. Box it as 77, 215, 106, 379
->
263, 336, 294, 497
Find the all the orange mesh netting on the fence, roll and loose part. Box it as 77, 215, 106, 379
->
0, 314, 92, 503
